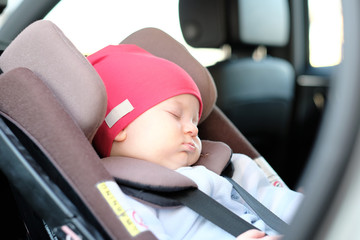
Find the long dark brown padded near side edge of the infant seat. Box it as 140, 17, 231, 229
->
0, 68, 155, 239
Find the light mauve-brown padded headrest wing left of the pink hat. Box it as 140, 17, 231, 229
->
0, 20, 107, 141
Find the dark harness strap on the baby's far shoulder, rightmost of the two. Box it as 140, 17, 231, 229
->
225, 177, 288, 233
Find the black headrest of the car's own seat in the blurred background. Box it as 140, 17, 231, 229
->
179, 0, 290, 48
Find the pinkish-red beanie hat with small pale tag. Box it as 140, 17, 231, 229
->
88, 44, 203, 157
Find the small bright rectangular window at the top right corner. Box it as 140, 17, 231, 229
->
308, 0, 343, 67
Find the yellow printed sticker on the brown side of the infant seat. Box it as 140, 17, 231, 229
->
97, 182, 141, 237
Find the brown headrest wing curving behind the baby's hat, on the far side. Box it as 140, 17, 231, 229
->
120, 28, 217, 122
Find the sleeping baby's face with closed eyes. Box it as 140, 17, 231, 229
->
110, 94, 201, 169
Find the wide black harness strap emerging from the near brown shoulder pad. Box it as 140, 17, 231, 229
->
163, 189, 257, 237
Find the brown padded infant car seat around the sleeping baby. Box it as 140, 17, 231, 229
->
0, 20, 281, 239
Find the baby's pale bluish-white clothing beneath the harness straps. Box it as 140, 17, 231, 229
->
122, 154, 303, 240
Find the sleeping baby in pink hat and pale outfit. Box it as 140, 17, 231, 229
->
88, 45, 302, 239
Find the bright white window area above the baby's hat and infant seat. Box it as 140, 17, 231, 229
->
45, 0, 226, 66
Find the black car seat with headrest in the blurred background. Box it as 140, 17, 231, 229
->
179, 0, 295, 184
